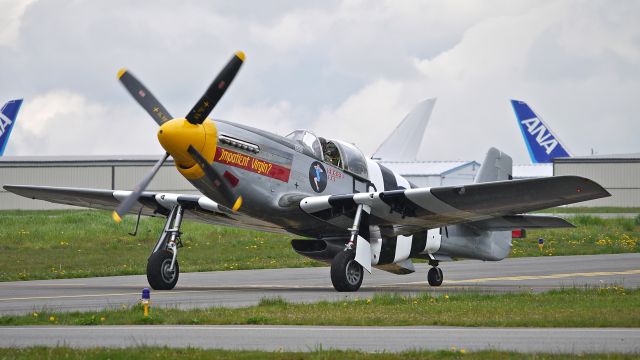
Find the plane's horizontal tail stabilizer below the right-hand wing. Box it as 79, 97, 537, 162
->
469, 215, 575, 231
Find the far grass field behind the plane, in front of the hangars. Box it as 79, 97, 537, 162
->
0, 210, 640, 281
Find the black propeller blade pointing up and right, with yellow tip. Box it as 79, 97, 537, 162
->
186, 51, 244, 124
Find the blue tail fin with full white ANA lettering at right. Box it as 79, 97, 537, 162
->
511, 100, 571, 164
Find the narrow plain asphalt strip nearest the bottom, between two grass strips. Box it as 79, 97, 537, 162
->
0, 326, 640, 354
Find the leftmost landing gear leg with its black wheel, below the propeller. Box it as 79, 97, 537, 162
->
147, 205, 184, 290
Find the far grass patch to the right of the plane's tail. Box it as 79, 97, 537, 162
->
510, 215, 640, 257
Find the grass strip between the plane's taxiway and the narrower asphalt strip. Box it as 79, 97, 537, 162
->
0, 286, 640, 327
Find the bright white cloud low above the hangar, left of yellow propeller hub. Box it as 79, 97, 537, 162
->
7, 89, 163, 155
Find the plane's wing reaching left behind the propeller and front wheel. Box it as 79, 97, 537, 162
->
4, 185, 284, 232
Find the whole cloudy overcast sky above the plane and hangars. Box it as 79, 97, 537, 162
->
0, 0, 640, 164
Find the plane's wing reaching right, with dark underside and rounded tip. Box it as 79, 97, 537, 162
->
300, 176, 610, 235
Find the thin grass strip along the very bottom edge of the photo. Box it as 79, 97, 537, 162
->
0, 347, 637, 360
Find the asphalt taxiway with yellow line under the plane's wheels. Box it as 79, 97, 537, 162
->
0, 254, 640, 315
